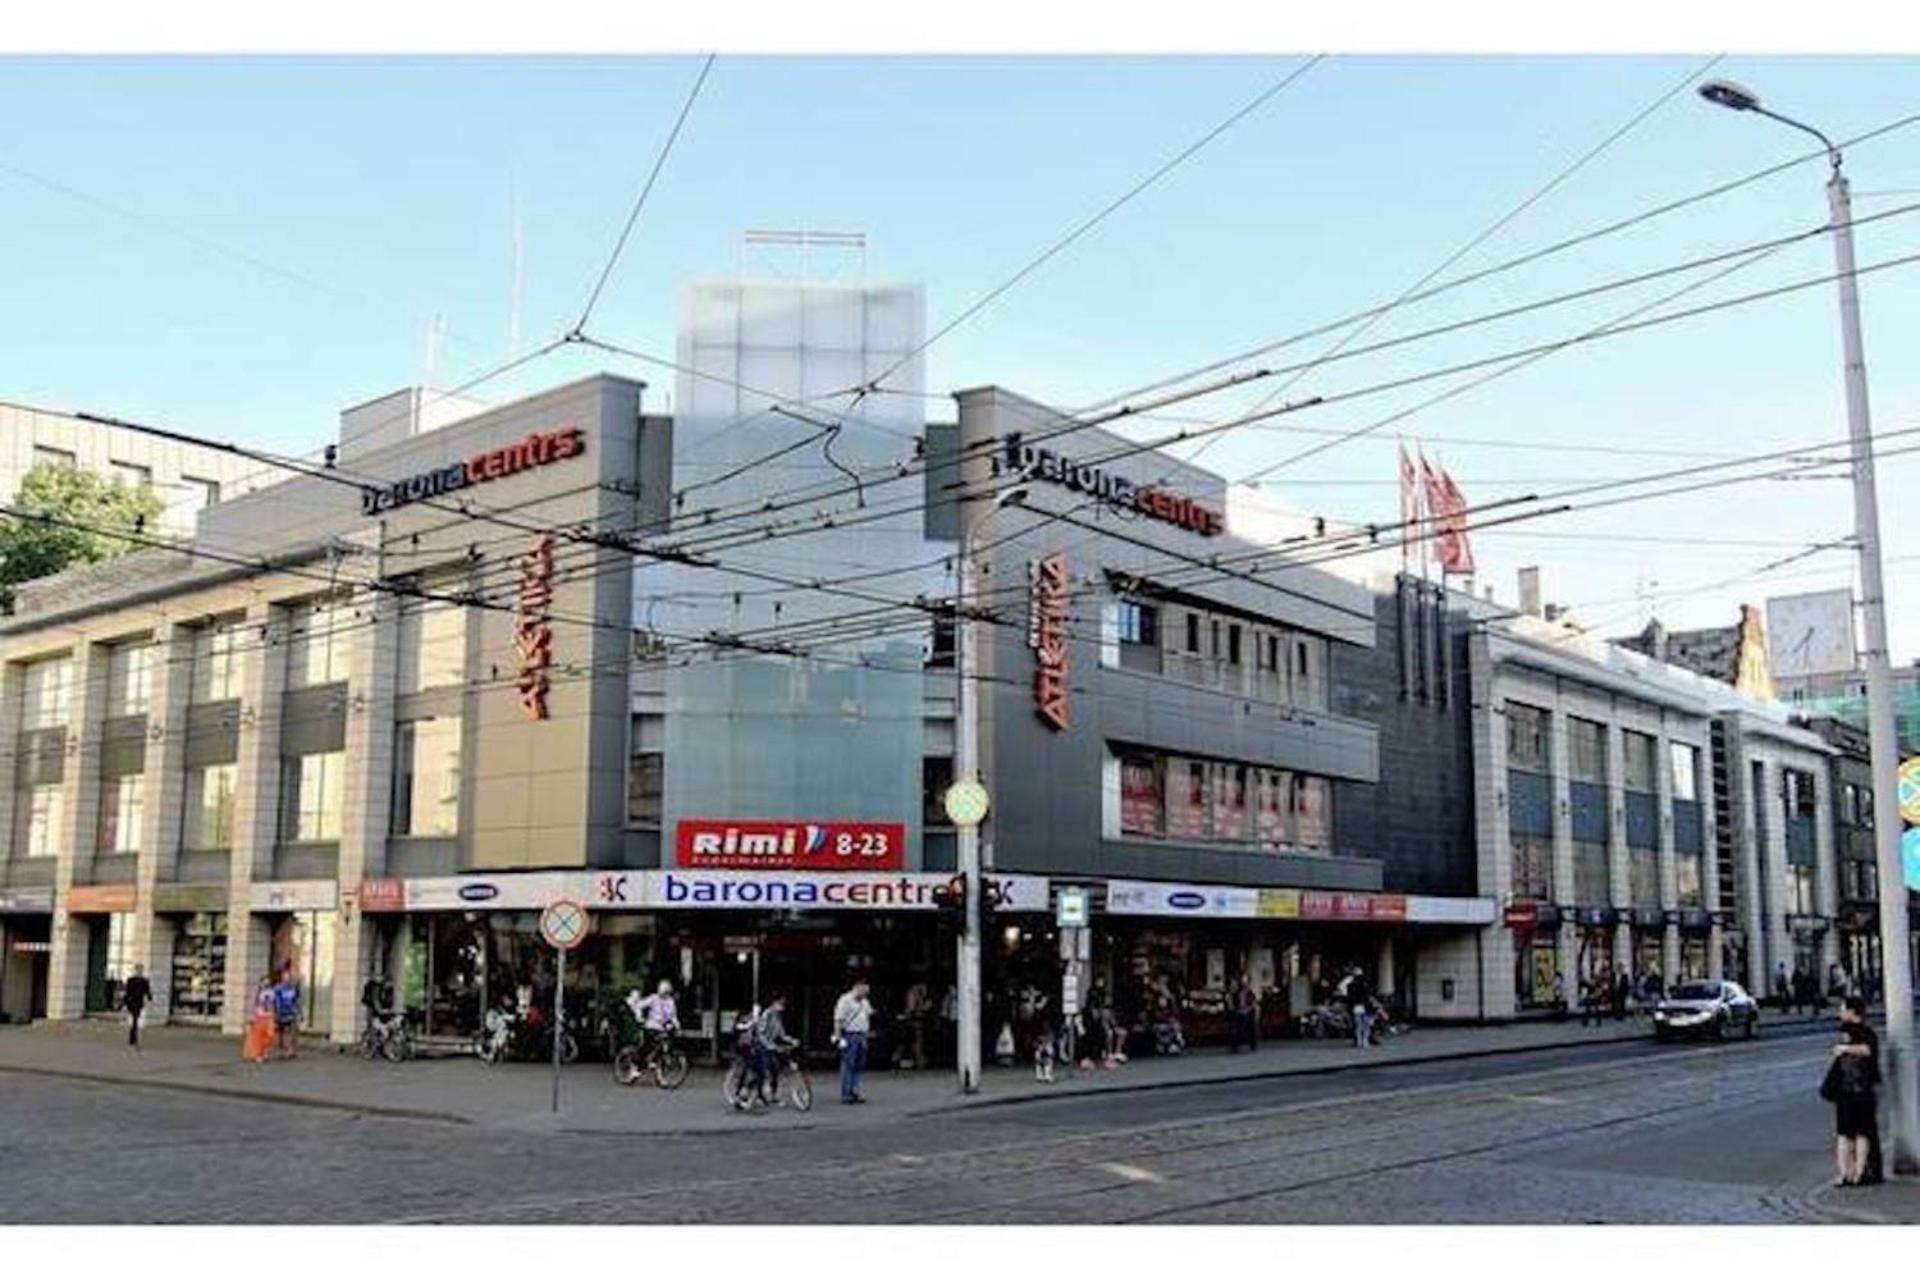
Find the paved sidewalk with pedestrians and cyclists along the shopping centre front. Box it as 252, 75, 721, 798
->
0, 1013, 1826, 1134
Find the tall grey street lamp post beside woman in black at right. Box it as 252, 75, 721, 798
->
1699, 81, 1920, 1173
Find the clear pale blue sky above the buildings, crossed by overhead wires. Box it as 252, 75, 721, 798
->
11, 56, 1920, 658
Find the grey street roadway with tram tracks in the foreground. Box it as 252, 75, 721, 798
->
0, 1032, 1832, 1224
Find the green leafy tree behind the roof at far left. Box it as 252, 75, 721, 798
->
0, 462, 161, 614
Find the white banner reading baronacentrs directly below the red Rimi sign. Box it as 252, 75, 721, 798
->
595, 869, 1052, 913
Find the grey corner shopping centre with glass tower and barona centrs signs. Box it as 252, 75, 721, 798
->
0, 286, 1505, 1044
